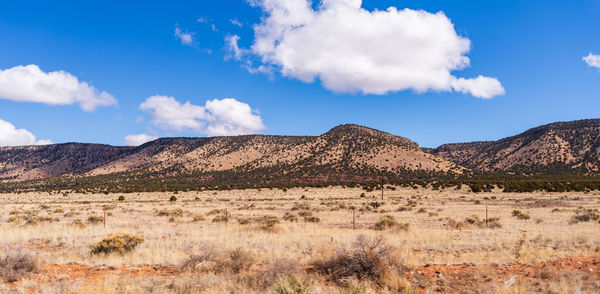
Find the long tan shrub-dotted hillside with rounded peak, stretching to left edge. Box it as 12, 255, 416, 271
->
0, 125, 464, 181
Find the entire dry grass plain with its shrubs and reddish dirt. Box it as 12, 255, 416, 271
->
0, 186, 600, 293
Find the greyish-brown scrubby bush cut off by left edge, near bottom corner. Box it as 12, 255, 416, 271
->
0, 250, 39, 283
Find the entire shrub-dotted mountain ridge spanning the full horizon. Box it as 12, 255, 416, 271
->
0, 119, 600, 186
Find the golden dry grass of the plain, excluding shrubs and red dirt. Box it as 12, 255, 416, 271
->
0, 187, 600, 293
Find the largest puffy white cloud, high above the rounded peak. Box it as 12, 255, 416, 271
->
233, 0, 504, 98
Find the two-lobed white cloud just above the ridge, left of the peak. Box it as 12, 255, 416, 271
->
140, 96, 265, 136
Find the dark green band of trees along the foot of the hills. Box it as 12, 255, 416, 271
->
0, 170, 600, 193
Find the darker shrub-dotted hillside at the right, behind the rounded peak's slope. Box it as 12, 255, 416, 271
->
431, 119, 600, 174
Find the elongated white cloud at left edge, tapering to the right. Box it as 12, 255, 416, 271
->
0, 64, 117, 111
